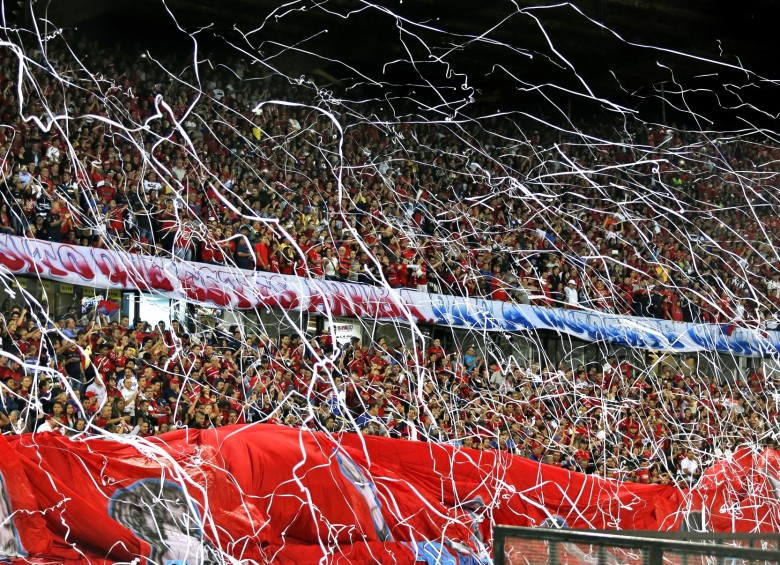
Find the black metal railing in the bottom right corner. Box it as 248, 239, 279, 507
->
493, 526, 780, 565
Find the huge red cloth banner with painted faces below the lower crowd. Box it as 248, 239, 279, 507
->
0, 425, 780, 564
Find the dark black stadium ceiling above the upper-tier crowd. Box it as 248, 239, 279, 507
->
15, 0, 780, 123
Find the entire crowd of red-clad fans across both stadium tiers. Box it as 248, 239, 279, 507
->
0, 34, 780, 483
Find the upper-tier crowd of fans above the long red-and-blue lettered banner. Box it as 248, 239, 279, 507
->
0, 33, 780, 329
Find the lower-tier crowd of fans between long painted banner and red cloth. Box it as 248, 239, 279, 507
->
0, 300, 778, 484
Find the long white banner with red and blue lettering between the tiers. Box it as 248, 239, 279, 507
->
0, 235, 780, 357
